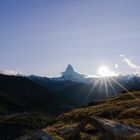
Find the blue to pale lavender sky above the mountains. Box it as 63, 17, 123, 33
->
0, 0, 140, 77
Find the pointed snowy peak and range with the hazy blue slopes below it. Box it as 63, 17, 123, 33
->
28, 65, 140, 108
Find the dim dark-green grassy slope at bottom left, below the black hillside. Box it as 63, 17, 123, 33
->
0, 112, 52, 140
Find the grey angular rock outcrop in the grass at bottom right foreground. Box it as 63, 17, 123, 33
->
67, 117, 140, 140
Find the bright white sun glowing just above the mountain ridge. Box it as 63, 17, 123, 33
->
97, 66, 116, 77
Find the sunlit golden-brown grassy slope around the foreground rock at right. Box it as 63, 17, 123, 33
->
44, 91, 140, 140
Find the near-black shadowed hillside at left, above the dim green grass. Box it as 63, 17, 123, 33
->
0, 75, 68, 115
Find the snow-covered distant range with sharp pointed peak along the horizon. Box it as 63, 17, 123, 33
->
28, 64, 140, 84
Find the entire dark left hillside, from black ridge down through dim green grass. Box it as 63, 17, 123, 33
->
0, 74, 74, 140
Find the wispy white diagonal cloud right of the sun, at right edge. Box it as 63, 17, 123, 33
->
120, 55, 140, 69
